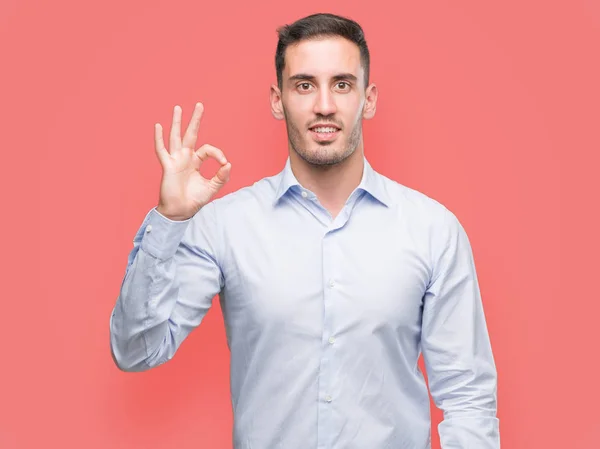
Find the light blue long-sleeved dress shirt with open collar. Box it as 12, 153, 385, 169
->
110, 157, 500, 449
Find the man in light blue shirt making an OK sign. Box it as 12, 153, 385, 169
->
110, 14, 500, 449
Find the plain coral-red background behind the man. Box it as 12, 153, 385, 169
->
0, 0, 600, 449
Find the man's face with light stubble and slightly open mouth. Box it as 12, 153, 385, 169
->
272, 37, 376, 165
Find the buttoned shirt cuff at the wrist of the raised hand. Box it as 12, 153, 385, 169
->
141, 207, 192, 260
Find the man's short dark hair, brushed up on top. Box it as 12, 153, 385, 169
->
275, 13, 370, 89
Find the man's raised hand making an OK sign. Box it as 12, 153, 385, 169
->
154, 103, 231, 220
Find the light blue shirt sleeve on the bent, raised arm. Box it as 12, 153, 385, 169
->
110, 202, 224, 371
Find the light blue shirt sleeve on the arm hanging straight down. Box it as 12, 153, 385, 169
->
421, 209, 500, 449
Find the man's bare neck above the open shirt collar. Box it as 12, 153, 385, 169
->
290, 145, 364, 217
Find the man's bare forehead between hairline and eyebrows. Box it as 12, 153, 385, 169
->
283, 37, 362, 79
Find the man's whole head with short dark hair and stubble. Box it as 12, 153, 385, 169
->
271, 14, 377, 165
